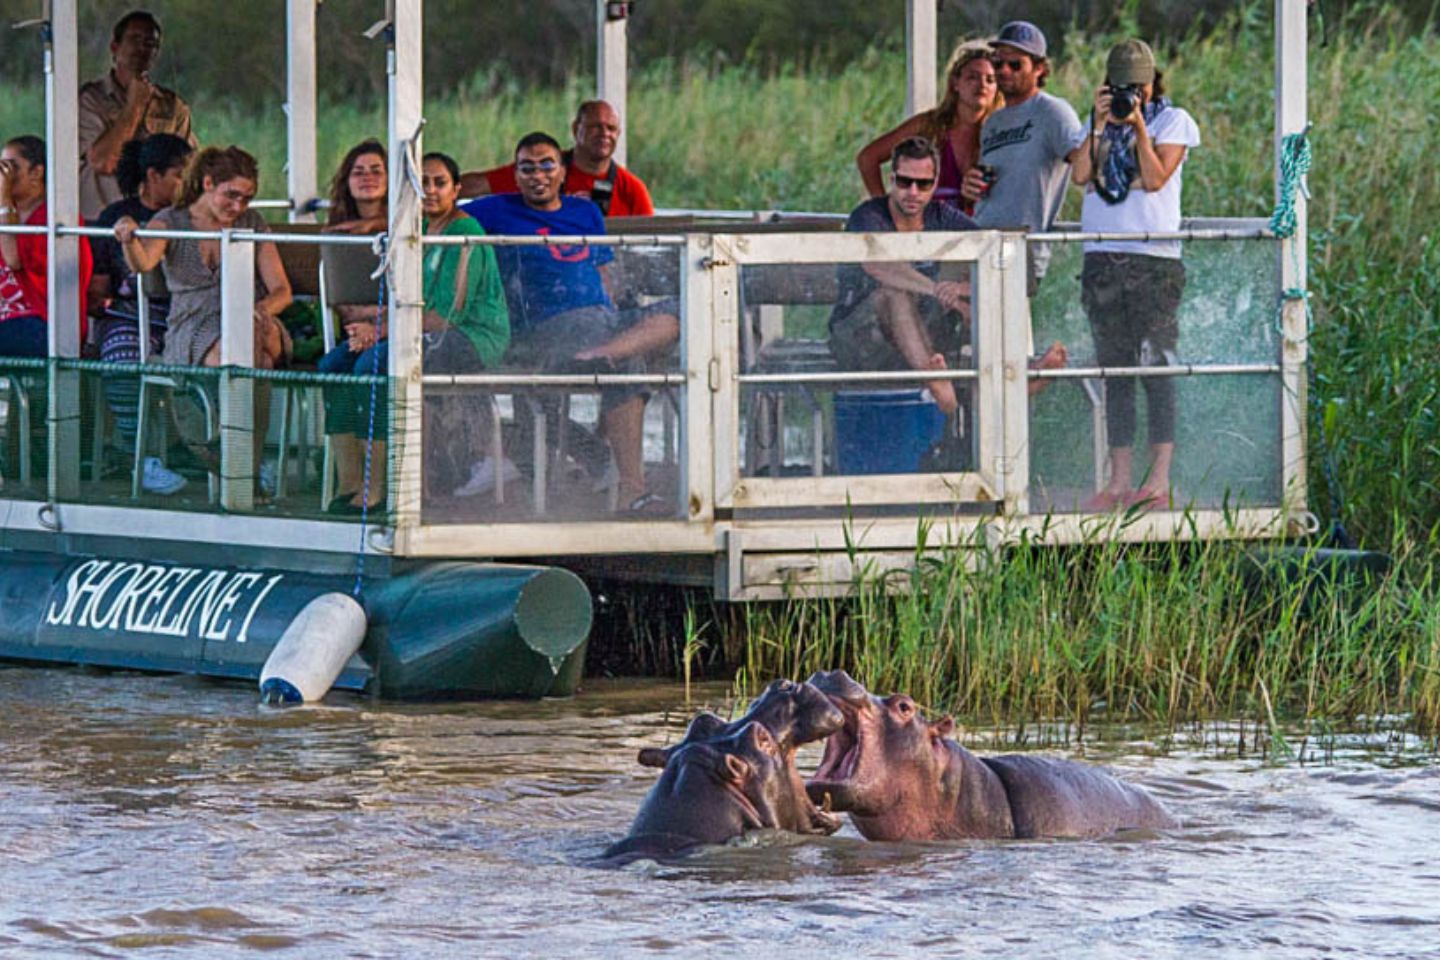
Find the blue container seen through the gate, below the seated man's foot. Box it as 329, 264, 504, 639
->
835, 390, 945, 474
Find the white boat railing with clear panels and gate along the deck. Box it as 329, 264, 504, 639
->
0, 220, 1300, 569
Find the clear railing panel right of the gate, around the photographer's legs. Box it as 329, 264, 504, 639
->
1031, 239, 1284, 512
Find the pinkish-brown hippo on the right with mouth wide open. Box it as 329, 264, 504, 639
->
806, 671, 1176, 841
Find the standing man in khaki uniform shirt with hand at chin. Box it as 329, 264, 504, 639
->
76, 10, 196, 220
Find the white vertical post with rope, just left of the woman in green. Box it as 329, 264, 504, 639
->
385, 0, 425, 553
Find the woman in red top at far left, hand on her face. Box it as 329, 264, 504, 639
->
0, 137, 91, 357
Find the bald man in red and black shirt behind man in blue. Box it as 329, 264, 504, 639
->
459, 99, 655, 217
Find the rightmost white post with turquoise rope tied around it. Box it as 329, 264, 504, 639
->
1274, 0, 1309, 512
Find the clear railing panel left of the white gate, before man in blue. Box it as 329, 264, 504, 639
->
422, 243, 685, 524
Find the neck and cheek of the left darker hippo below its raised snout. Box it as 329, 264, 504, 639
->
602, 721, 840, 865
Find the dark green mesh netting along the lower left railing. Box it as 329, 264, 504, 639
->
0, 360, 403, 526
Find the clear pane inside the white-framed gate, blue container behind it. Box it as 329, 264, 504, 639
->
739, 262, 975, 478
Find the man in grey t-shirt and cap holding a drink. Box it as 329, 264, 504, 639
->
960, 20, 1084, 295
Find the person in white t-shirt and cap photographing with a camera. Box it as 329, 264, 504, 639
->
1071, 40, 1200, 512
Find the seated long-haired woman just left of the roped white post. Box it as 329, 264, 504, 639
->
318, 140, 390, 512
